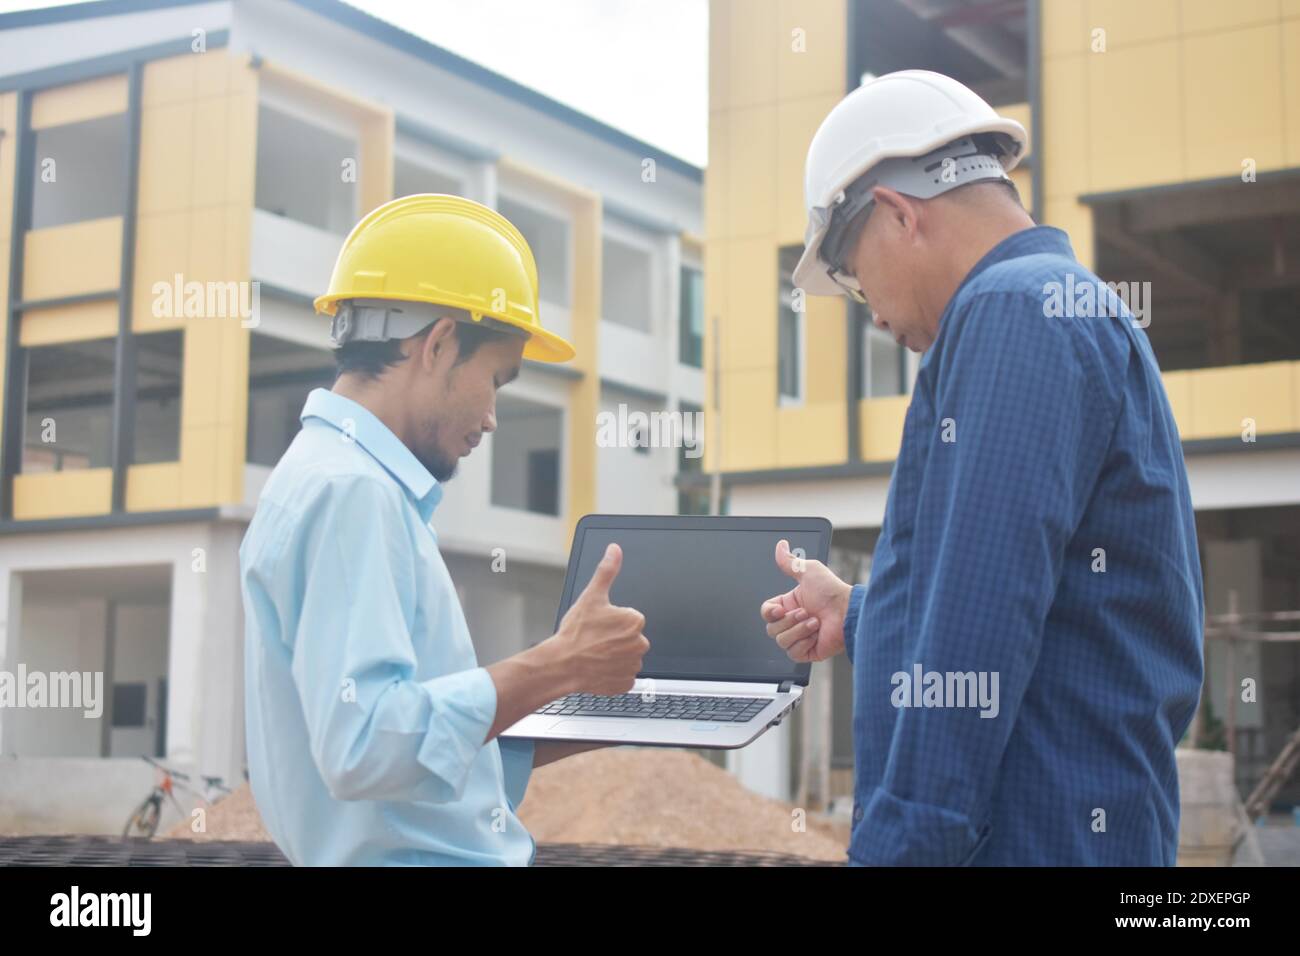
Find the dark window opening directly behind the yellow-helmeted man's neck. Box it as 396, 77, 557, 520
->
246, 332, 334, 467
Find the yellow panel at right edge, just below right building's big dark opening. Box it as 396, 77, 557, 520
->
1183, 362, 1300, 438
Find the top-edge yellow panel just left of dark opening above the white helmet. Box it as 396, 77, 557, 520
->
776, 0, 848, 99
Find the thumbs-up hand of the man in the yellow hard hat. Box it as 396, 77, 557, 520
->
553, 544, 650, 695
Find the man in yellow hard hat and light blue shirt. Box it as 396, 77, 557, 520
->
239, 195, 649, 865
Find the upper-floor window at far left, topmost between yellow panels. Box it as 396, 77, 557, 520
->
31, 113, 126, 229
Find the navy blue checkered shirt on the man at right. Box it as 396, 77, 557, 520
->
845, 226, 1204, 866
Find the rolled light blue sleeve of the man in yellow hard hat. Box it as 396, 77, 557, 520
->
293, 479, 497, 803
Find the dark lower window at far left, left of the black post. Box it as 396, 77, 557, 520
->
21, 338, 116, 473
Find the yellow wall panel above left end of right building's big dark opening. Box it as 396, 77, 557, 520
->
1081, 40, 1186, 191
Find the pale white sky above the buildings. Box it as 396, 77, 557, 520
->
0, 0, 709, 166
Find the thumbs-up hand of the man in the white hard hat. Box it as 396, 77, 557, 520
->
762, 538, 853, 663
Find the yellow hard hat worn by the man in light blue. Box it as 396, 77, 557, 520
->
316, 193, 575, 362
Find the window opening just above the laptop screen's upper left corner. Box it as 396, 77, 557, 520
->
491, 395, 564, 515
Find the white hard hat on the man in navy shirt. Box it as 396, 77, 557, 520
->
793, 70, 1028, 295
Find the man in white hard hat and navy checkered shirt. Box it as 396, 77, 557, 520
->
761, 70, 1204, 865
